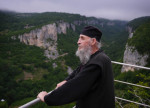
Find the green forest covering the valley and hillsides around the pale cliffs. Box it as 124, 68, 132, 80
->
0, 11, 150, 108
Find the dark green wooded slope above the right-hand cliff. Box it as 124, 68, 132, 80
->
128, 17, 150, 66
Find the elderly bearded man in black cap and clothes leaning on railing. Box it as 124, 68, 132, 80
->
38, 26, 115, 108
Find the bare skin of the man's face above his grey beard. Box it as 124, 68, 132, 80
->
77, 35, 91, 50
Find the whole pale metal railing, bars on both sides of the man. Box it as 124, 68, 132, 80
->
19, 61, 150, 108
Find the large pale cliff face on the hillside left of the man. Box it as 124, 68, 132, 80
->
17, 22, 75, 59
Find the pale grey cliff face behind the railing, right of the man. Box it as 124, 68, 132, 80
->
121, 27, 148, 72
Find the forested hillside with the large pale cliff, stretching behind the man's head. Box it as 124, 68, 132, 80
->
0, 11, 128, 108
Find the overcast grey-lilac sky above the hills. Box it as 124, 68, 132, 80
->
0, 0, 150, 20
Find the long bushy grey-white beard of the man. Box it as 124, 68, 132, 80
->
76, 45, 92, 65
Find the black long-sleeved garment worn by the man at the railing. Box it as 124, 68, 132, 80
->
44, 50, 115, 108
